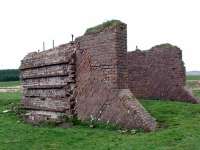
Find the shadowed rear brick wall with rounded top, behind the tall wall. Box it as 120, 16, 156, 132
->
128, 44, 199, 103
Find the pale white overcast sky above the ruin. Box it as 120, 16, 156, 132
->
0, 0, 200, 71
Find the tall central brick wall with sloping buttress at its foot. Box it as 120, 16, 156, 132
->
76, 23, 156, 131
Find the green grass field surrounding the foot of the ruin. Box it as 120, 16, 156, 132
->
0, 79, 200, 150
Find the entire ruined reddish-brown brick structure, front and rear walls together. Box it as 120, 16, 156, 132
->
20, 21, 199, 131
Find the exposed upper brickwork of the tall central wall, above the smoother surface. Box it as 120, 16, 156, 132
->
76, 23, 128, 88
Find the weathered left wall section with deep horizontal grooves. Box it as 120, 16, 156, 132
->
20, 43, 75, 123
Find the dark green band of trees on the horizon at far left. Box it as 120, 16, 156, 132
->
0, 69, 19, 82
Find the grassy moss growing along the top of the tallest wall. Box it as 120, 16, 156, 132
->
85, 20, 122, 34
